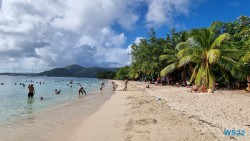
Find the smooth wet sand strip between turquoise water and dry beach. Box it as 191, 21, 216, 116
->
0, 81, 111, 141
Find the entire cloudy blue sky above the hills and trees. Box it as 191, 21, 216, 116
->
0, 0, 250, 73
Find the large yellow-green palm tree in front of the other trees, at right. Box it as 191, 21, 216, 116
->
177, 28, 239, 89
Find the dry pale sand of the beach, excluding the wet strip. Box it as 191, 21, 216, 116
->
71, 81, 250, 141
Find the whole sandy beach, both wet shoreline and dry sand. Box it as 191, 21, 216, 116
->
1, 80, 250, 141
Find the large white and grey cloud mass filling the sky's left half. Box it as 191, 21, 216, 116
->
0, 0, 138, 70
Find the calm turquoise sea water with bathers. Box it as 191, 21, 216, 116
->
0, 75, 103, 126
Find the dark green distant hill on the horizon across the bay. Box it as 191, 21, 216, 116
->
38, 64, 116, 78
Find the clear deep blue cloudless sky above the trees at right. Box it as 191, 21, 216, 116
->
124, 0, 250, 45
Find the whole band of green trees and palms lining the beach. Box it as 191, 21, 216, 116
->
116, 16, 250, 88
